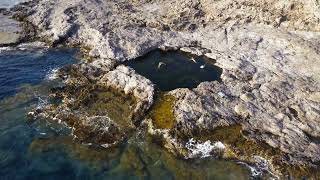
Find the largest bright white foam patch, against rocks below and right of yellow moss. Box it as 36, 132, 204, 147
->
186, 138, 225, 159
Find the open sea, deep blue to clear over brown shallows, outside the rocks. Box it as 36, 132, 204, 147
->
0, 49, 250, 180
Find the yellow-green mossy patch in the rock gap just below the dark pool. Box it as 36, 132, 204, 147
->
148, 94, 175, 129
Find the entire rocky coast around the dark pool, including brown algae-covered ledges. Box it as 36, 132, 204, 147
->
4, 0, 320, 175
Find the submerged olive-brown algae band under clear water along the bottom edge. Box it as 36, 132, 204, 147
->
28, 136, 249, 180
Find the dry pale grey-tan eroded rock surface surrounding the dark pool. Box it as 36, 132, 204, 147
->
16, 0, 320, 169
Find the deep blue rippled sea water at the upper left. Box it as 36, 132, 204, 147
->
0, 49, 77, 100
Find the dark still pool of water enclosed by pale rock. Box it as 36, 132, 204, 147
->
125, 50, 222, 91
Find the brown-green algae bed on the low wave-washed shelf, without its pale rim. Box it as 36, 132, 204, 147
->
44, 80, 137, 144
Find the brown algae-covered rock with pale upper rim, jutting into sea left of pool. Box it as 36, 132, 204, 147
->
32, 64, 154, 147
